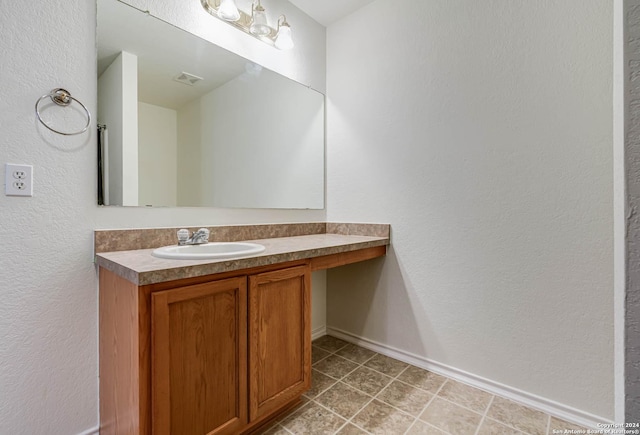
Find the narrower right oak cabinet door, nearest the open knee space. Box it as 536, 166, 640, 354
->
249, 266, 311, 420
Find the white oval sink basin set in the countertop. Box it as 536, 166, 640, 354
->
151, 242, 265, 260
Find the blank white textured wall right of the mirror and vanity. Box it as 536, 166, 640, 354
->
327, 0, 614, 421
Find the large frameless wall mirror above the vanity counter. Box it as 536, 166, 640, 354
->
97, 0, 325, 209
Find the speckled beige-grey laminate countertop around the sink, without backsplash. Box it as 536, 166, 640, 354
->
96, 234, 390, 285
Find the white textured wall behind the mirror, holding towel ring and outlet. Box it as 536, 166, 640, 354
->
0, 0, 326, 434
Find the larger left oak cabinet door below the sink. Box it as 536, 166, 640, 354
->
151, 277, 247, 435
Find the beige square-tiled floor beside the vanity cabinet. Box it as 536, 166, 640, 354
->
264, 335, 585, 435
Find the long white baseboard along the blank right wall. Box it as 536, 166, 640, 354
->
326, 326, 613, 429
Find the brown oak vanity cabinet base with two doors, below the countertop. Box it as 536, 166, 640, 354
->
100, 262, 311, 435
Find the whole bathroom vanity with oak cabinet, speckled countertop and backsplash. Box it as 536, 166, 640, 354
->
96, 223, 389, 434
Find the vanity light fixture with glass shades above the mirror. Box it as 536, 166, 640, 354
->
200, 0, 293, 50
